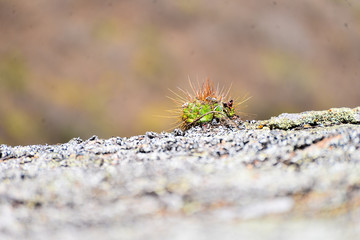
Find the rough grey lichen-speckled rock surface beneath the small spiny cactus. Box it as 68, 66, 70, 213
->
0, 107, 360, 240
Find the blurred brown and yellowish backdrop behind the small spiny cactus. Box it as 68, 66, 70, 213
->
0, 0, 360, 145
